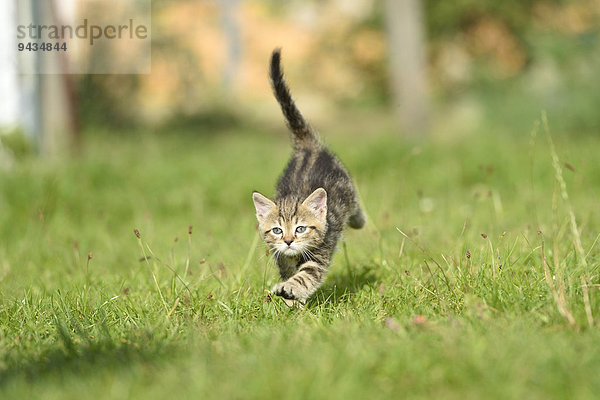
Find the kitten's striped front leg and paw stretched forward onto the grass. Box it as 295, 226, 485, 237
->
273, 261, 327, 304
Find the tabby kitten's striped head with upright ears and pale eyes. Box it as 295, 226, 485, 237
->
252, 188, 327, 256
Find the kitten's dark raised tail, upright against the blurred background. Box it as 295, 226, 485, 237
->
270, 49, 318, 148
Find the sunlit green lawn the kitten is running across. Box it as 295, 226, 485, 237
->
0, 117, 600, 399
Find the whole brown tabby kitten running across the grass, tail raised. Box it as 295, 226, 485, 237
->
252, 49, 366, 303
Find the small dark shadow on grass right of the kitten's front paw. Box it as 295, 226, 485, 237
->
310, 265, 377, 306
